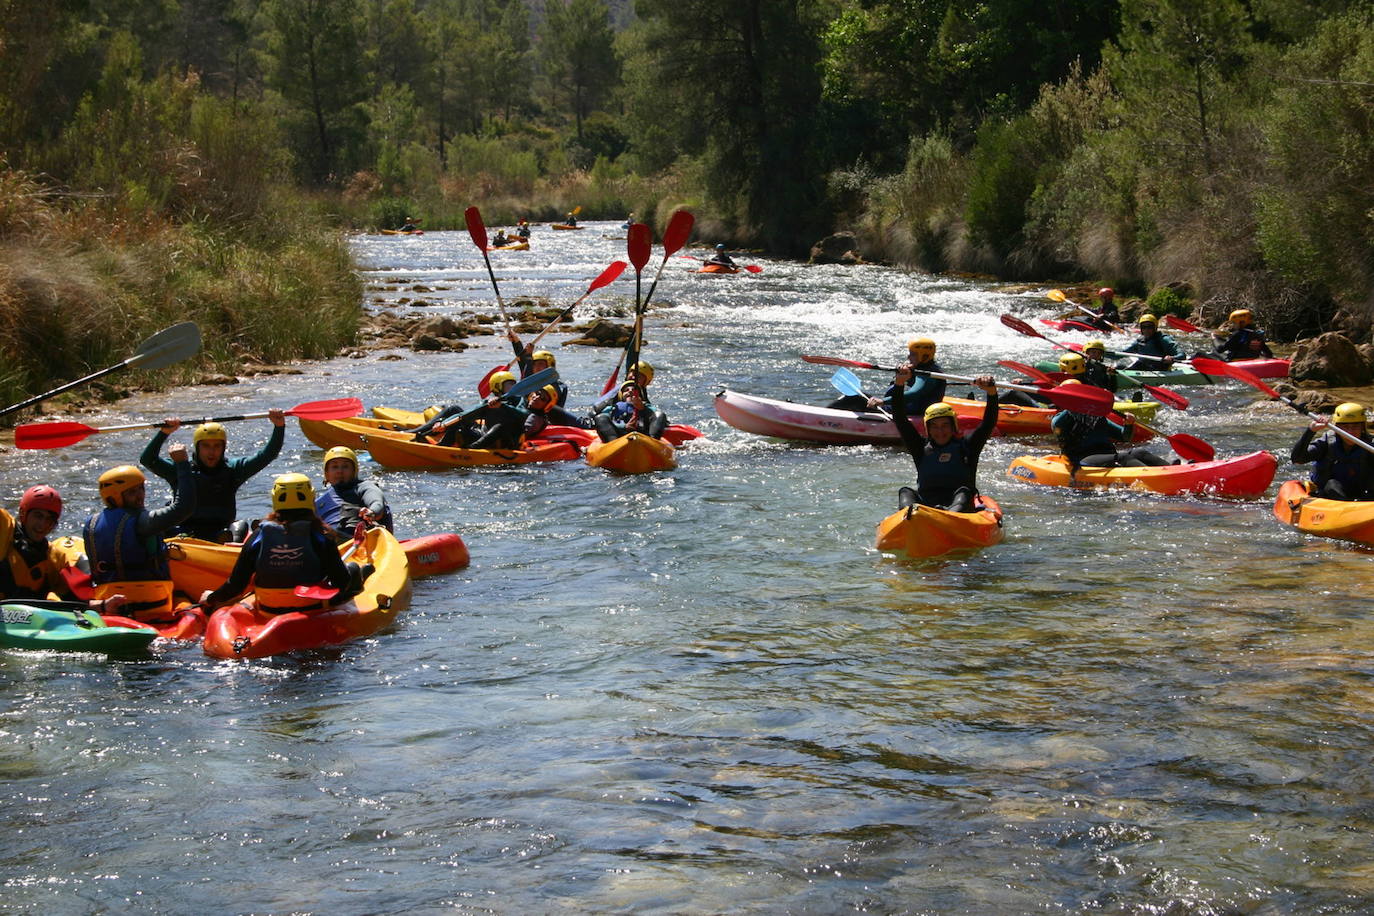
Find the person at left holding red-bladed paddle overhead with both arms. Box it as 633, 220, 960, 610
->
139, 408, 286, 544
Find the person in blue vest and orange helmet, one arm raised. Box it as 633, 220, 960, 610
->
84, 442, 196, 621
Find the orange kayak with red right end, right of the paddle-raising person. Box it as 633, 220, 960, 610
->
1007, 452, 1278, 497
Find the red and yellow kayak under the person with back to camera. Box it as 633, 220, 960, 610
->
202, 527, 411, 658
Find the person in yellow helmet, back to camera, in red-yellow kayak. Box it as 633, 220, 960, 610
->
201, 474, 365, 614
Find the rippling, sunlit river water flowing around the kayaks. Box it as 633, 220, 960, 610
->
0, 222, 1374, 913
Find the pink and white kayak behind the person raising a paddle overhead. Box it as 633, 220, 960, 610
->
716, 389, 980, 445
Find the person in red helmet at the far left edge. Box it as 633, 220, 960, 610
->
0, 483, 124, 614
